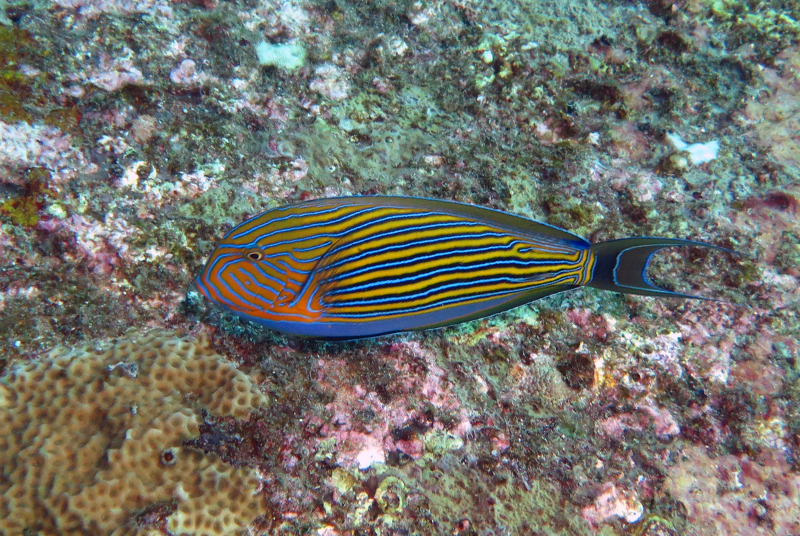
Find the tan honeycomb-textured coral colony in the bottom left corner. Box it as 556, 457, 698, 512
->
0, 333, 268, 535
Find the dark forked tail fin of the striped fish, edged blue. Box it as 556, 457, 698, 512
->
588, 237, 736, 301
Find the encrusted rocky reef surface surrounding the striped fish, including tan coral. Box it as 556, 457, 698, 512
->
0, 0, 800, 536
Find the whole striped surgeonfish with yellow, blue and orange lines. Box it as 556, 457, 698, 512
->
195, 196, 729, 338
